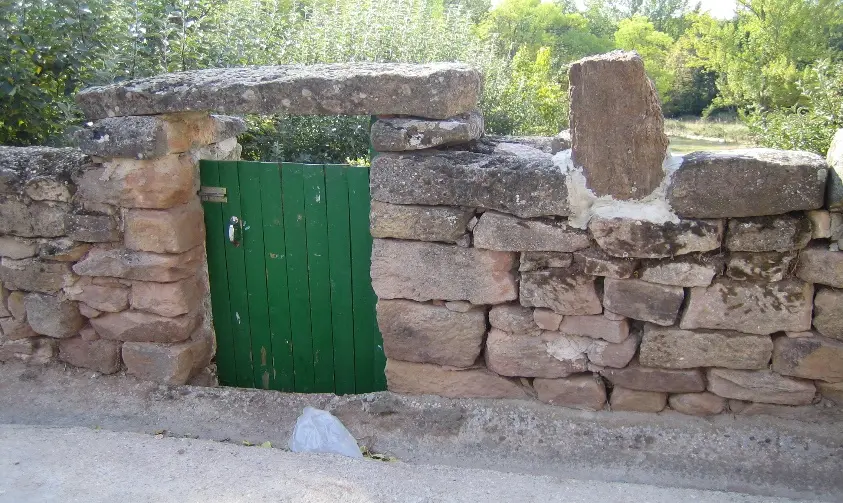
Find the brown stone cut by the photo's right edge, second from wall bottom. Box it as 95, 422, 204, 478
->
772, 334, 843, 382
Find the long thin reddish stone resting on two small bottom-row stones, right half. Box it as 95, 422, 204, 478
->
600, 362, 705, 393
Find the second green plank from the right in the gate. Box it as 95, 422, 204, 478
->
325, 165, 355, 395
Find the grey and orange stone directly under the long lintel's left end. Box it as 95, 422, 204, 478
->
74, 113, 246, 159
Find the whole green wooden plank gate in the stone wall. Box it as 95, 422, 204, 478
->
200, 161, 386, 394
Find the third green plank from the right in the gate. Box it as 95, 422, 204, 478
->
304, 166, 334, 393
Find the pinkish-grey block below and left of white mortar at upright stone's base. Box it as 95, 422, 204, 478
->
474, 211, 590, 252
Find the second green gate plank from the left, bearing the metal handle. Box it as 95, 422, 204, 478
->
218, 161, 255, 388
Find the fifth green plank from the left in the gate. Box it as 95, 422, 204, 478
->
281, 163, 316, 393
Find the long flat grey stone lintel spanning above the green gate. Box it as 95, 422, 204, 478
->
76, 63, 481, 119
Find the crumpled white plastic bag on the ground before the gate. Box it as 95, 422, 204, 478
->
289, 407, 363, 458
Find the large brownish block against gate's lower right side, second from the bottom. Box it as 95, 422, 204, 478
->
377, 300, 486, 368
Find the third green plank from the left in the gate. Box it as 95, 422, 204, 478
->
237, 161, 273, 389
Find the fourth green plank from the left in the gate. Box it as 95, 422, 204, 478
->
260, 164, 295, 391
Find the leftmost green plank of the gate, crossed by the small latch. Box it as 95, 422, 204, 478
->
199, 161, 237, 386
